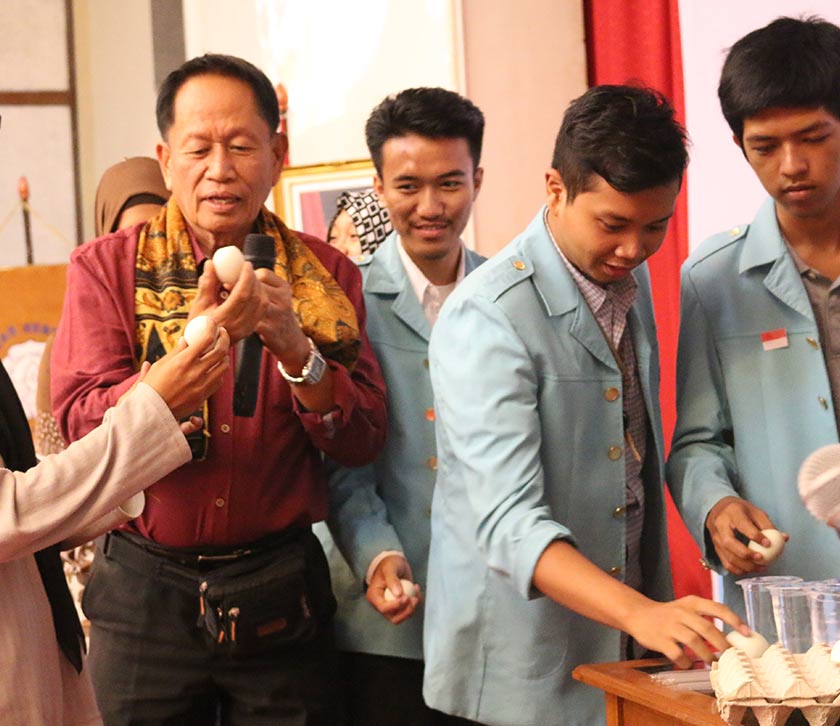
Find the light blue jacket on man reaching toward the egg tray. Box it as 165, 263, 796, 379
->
423, 211, 672, 726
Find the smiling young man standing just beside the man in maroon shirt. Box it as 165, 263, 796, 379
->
320, 88, 484, 726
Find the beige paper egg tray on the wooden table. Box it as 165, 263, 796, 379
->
709, 644, 840, 726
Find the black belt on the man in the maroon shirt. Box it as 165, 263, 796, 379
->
102, 527, 309, 571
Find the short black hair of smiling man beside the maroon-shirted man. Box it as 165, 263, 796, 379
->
365, 88, 484, 177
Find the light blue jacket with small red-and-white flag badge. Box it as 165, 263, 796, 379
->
667, 199, 840, 616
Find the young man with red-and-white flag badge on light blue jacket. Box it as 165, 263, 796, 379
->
667, 18, 840, 612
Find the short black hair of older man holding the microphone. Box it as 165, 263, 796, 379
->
157, 53, 280, 140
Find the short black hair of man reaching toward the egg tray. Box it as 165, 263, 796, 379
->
551, 85, 688, 202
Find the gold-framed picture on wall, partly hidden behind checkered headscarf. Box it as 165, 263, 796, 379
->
274, 159, 376, 240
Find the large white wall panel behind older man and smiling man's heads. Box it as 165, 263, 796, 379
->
183, 0, 461, 166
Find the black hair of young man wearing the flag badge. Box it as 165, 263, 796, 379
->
718, 16, 840, 142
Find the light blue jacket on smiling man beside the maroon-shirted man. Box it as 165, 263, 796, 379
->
318, 233, 484, 659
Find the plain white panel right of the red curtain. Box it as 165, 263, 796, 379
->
680, 0, 840, 248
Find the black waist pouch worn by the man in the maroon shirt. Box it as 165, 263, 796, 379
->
198, 530, 336, 655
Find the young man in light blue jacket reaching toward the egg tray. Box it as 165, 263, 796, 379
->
423, 86, 741, 726
